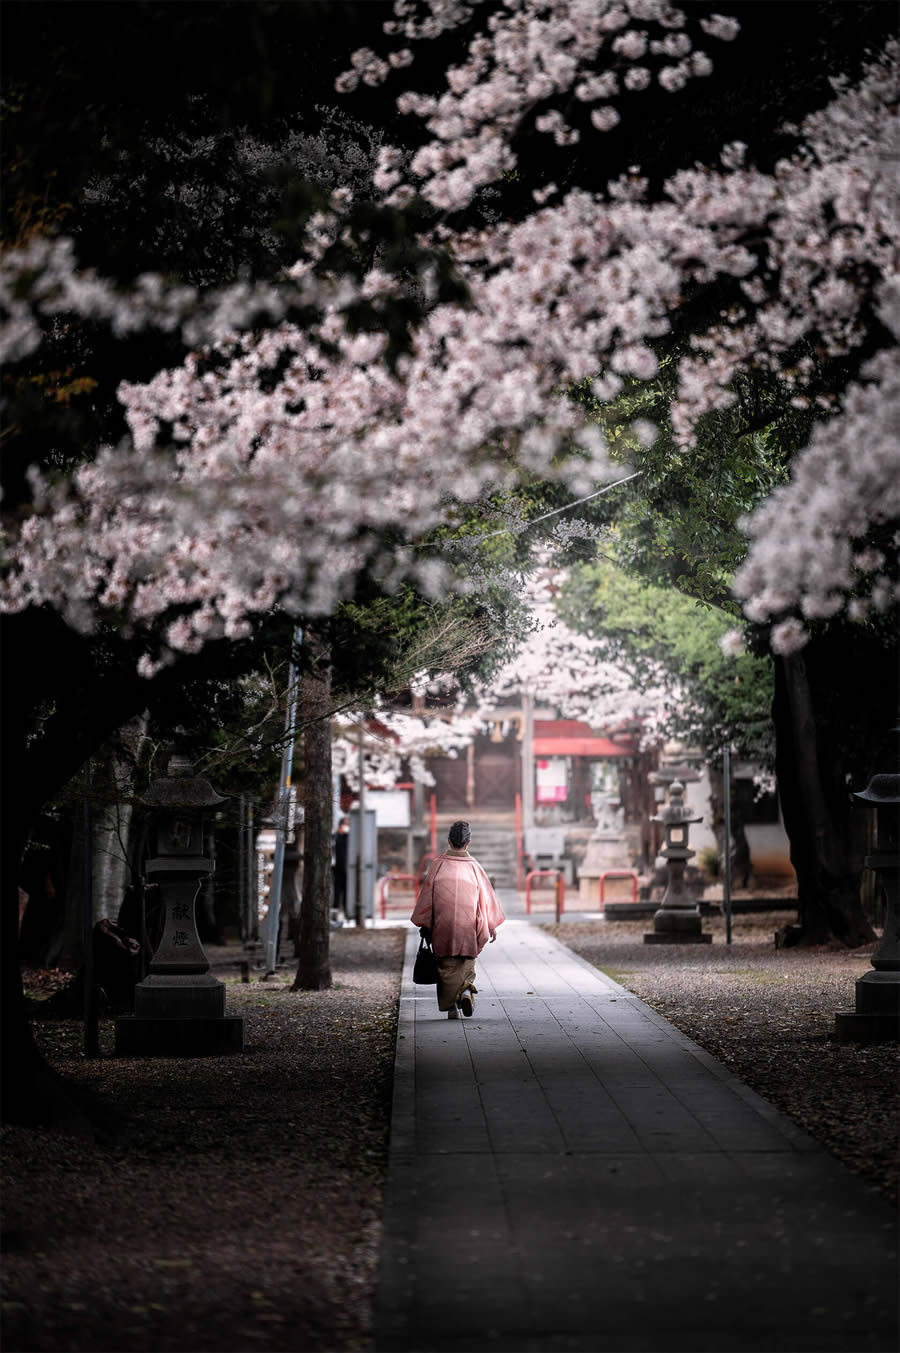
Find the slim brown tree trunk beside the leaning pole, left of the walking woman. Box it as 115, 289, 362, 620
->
294, 636, 333, 992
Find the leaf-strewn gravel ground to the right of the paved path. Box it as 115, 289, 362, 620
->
548, 912, 900, 1203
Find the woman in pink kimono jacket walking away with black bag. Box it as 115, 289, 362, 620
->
410, 823, 506, 1019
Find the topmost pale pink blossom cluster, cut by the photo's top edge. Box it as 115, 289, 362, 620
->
337, 0, 739, 211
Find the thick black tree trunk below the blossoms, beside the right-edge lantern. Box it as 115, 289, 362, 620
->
773, 626, 896, 947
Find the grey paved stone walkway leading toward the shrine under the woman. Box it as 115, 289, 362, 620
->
375, 919, 897, 1353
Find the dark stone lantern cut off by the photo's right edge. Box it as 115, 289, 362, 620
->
835, 775, 900, 1043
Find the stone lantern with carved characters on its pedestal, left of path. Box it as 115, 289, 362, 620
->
115, 752, 244, 1057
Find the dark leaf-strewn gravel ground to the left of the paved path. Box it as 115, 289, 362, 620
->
1, 928, 405, 1353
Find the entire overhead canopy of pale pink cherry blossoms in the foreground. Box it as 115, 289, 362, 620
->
0, 0, 900, 1109
